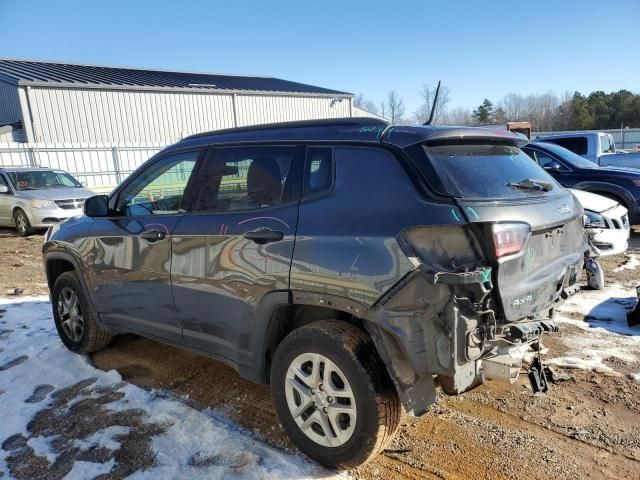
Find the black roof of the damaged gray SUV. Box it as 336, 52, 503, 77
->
175, 117, 527, 152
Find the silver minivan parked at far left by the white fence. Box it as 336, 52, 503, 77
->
0, 167, 94, 236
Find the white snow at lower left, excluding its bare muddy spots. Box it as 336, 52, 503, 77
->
0, 297, 345, 480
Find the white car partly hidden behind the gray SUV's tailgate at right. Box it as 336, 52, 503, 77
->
570, 189, 631, 257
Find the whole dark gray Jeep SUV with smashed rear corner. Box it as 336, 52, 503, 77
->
43, 119, 584, 467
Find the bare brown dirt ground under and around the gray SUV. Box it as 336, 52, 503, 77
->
0, 226, 640, 480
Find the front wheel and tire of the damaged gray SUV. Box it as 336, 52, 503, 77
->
51, 272, 112, 354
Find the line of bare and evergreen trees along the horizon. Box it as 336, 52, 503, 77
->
354, 85, 640, 132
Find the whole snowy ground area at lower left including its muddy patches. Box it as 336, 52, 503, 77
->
0, 297, 342, 480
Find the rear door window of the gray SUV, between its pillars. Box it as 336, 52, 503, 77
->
197, 146, 294, 212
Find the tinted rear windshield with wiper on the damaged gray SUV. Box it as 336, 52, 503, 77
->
424, 144, 562, 200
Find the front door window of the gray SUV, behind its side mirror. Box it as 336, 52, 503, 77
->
117, 151, 200, 216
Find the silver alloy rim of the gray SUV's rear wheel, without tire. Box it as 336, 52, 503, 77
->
285, 353, 357, 447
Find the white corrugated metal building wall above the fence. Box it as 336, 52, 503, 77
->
27, 87, 351, 144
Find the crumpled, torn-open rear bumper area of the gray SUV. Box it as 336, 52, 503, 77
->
366, 264, 577, 415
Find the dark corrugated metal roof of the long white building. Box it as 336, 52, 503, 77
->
0, 59, 351, 95
